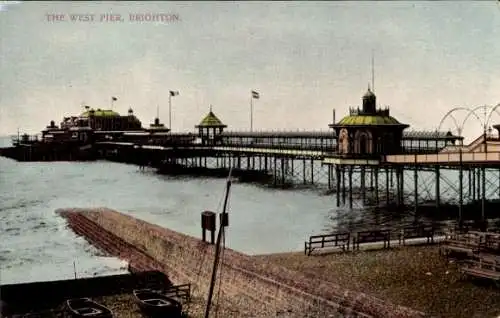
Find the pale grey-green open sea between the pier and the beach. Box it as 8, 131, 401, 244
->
0, 137, 337, 285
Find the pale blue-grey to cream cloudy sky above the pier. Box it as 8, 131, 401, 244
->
0, 0, 500, 139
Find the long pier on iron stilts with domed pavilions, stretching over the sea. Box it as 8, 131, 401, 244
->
0, 90, 500, 226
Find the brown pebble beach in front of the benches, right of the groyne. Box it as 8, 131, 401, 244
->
255, 245, 500, 318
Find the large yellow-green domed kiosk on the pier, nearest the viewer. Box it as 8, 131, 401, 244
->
323, 87, 410, 209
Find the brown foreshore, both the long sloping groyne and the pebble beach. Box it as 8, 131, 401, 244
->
2, 208, 500, 318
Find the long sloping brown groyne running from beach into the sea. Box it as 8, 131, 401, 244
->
58, 208, 426, 318
